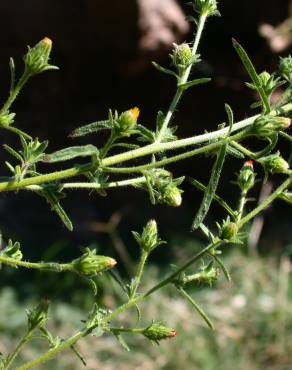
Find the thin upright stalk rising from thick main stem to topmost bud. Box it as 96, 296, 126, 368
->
156, 14, 207, 143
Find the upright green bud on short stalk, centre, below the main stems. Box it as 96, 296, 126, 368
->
132, 220, 165, 253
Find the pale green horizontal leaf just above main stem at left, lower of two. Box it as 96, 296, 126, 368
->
43, 144, 98, 163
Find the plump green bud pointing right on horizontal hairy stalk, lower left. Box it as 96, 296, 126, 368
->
71, 248, 117, 277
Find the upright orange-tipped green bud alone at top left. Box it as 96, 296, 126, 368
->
24, 37, 58, 76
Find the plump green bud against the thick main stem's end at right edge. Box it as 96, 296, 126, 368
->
252, 115, 291, 139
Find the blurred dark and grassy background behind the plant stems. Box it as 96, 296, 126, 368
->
0, 0, 292, 370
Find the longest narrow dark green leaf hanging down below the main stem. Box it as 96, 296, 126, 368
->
192, 144, 227, 230
